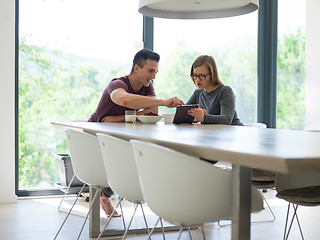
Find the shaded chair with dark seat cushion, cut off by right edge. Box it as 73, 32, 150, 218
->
275, 173, 320, 239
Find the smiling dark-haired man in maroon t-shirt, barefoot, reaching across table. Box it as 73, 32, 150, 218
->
88, 49, 184, 217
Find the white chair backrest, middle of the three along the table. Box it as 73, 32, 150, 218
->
97, 133, 143, 202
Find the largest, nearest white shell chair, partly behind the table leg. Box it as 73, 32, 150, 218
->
130, 140, 263, 239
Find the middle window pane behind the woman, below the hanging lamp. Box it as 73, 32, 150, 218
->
154, 11, 258, 123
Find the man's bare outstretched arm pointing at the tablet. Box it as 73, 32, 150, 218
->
110, 88, 184, 109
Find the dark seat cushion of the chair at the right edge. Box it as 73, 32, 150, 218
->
276, 186, 320, 206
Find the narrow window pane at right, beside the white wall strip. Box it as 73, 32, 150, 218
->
277, 0, 306, 130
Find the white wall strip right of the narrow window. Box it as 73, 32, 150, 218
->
306, 0, 320, 130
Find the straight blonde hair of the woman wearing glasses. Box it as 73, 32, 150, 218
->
190, 55, 222, 86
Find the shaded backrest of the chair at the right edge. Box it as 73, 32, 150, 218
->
275, 173, 320, 192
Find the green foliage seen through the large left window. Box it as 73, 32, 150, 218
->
19, 40, 101, 188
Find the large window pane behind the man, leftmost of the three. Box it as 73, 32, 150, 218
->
19, 0, 142, 190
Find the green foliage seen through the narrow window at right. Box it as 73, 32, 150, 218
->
277, 29, 305, 129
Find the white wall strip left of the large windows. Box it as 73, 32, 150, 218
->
0, 0, 16, 203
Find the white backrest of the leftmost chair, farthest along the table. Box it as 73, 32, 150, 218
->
65, 129, 109, 187
